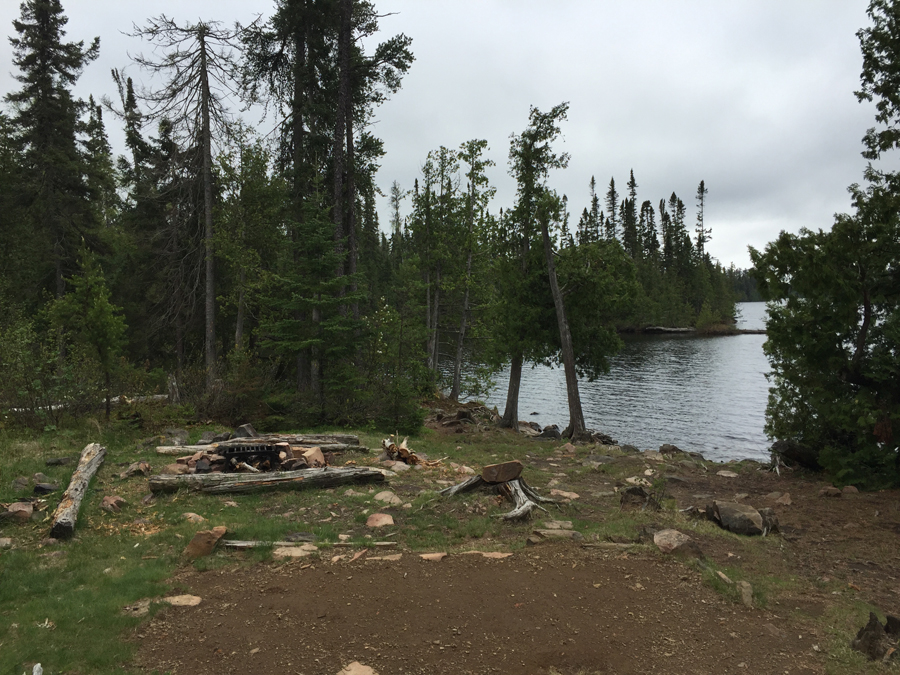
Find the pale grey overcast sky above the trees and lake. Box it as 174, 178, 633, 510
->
0, 0, 874, 267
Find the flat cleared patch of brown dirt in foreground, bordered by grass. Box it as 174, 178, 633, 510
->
135, 543, 824, 675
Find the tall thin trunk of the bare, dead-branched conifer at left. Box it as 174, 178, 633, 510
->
198, 30, 216, 391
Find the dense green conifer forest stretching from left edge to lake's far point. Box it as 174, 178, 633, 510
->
0, 0, 759, 431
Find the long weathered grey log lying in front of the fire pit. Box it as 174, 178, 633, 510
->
149, 467, 384, 494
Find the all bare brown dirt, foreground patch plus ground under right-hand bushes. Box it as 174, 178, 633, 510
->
128, 430, 900, 675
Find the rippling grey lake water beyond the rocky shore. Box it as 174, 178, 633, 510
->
488, 302, 771, 461
